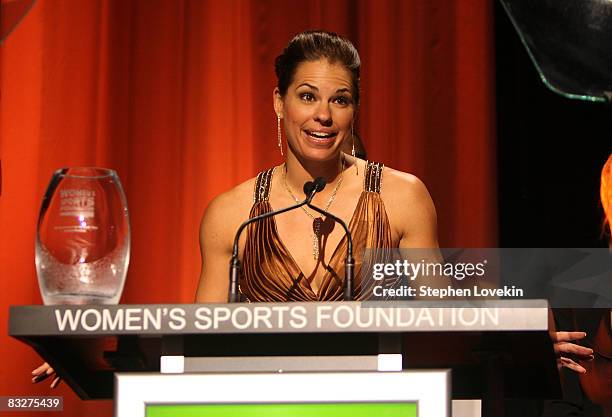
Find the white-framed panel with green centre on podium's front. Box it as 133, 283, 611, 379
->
115, 370, 451, 417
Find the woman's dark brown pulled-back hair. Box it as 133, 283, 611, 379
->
274, 30, 361, 105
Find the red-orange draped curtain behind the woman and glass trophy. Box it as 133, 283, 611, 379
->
0, 0, 497, 416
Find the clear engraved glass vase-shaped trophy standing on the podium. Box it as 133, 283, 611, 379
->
36, 168, 130, 305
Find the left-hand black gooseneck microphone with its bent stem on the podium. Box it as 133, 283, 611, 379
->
228, 177, 326, 303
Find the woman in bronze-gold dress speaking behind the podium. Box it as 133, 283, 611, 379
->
196, 31, 438, 302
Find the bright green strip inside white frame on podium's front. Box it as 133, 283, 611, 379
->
146, 402, 417, 417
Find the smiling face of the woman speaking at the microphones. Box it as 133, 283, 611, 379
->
274, 59, 355, 161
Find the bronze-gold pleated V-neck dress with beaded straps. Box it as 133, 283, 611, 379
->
240, 162, 391, 302
